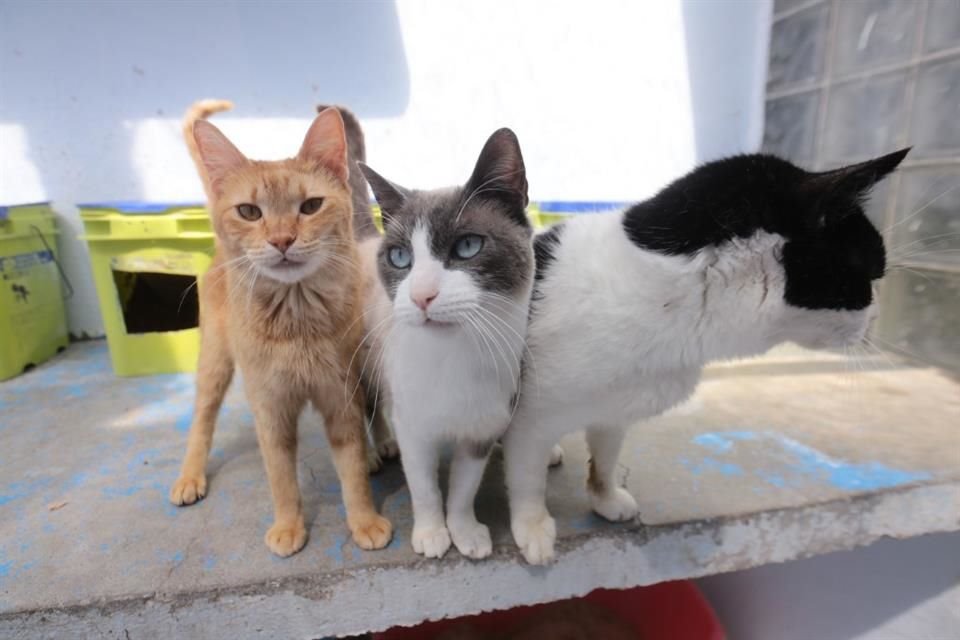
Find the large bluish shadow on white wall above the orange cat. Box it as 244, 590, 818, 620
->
0, 0, 409, 200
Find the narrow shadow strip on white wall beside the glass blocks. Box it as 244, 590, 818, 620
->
681, 0, 773, 163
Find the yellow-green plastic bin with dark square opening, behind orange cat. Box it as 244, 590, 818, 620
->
78, 202, 214, 376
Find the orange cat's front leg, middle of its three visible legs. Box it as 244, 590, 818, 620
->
247, 385, 307, 558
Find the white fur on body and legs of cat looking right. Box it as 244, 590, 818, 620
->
504, 213, 871, 564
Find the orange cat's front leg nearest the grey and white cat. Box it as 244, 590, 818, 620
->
314, 385, 393, 549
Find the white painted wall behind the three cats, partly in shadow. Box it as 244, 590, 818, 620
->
0, 0, 771, 335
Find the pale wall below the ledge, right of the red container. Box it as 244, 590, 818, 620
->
699, 533, 960, 640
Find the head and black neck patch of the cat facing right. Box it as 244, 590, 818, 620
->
623, 149, 909, 347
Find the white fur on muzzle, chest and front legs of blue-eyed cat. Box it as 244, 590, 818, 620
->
385, 227, 530, 558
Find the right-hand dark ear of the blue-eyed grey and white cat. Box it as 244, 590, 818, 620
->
466, 128, 528, 209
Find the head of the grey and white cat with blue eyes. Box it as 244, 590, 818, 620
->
360, 129, 533, 325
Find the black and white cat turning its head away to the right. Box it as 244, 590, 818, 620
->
504, 150, 907, 564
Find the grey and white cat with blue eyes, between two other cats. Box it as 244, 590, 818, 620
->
361, 129, 534, 558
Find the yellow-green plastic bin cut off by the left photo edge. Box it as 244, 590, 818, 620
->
0, 202, 69, 380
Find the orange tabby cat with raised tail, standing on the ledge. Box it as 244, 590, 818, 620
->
170, 100, 392, 556
